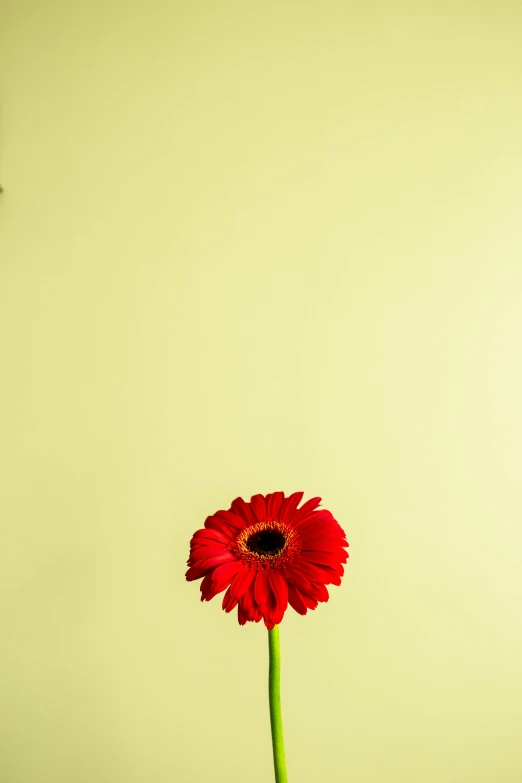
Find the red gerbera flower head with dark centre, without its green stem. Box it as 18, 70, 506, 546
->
186, 492, 348, 629
